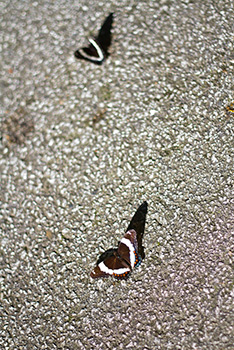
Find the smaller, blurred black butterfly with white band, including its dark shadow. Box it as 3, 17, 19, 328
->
74, 13, 113, 65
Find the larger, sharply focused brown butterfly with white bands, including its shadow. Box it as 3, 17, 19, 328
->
90, 202, 147, 279
